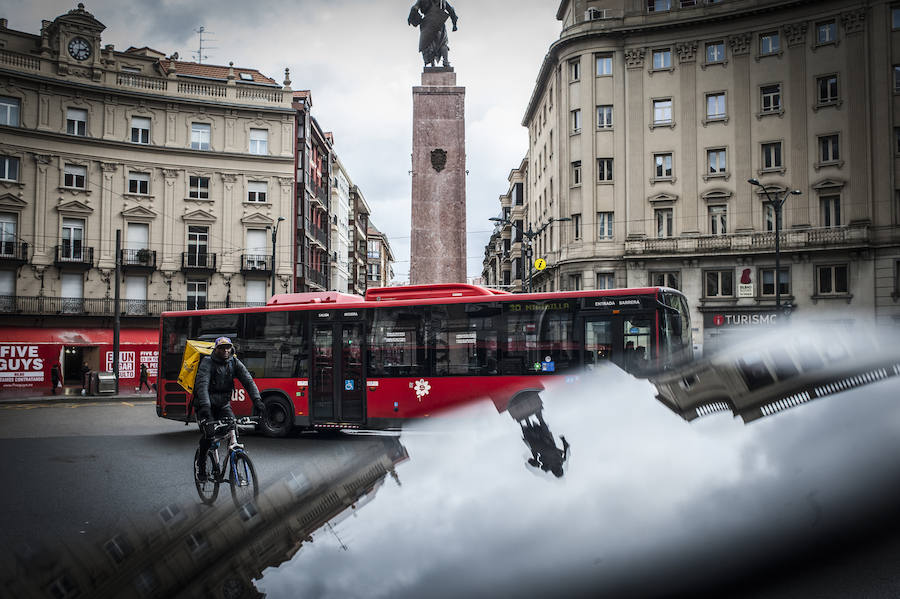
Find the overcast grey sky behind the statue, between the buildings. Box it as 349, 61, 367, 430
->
8, 0, 560, 281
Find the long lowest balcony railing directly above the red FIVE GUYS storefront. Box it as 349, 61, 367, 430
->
0, 295, 259, 317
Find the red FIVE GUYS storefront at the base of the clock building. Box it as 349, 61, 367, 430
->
0, 327, 159, 395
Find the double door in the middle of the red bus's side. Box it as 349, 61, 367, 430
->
309, 311, 366, 424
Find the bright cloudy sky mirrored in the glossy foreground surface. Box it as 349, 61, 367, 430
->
259, 324, 900, 597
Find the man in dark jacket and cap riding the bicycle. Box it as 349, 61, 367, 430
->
194, 337, 265, 480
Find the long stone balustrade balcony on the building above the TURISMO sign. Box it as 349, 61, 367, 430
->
625, 226, 869, 256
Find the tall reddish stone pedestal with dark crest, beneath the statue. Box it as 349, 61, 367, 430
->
409, 67, 466, 285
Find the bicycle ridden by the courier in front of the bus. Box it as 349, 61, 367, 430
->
194, 417, 259, 508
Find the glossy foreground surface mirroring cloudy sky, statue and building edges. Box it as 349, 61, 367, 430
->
10, 324, 900, 598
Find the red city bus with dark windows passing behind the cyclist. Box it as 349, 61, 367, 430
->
156, 284, 692, 436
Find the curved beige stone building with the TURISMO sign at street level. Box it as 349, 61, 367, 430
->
488, 0, 900, 348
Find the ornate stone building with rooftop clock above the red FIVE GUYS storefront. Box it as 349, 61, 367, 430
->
0, 5, 296, 388
